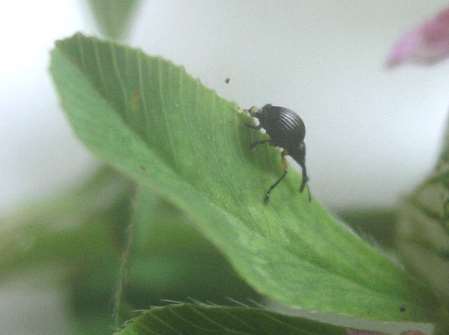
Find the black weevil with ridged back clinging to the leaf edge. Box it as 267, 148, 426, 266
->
246, 104, 311, 202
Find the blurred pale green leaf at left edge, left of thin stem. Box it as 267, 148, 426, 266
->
0, 168, 131, 279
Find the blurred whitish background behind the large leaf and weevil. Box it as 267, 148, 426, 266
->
0, 0, 449, 334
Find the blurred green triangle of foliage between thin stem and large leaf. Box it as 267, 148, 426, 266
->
126, 191, 257, 309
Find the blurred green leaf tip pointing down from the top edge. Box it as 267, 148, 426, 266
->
88, 0, 140, 39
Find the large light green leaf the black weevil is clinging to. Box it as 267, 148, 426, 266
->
51, 34, 435, 321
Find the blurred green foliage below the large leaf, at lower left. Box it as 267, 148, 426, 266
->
0, 168, 258, 334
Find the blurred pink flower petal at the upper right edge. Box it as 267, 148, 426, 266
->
387, 8, 449, 67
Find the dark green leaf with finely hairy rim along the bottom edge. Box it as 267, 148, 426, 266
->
116, 304, 346, 335
